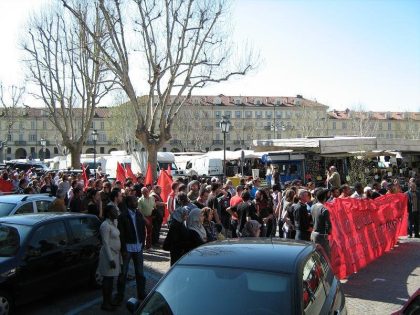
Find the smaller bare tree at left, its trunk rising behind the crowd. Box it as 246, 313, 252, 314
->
22, 5, 114, 167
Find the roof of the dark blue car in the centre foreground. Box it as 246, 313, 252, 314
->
177, 238, 315, 273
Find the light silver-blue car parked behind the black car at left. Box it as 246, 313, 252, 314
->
0, 194, 55, 217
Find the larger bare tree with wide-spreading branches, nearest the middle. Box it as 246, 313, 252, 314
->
62, 0, 252, 180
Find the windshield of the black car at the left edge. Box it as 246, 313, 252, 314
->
0, 223, 31, 257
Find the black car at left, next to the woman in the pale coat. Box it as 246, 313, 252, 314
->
0, 213, 100, 314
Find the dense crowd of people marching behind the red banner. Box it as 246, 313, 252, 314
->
2, 166, 420, 310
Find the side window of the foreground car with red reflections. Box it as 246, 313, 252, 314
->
302, 253, 326, 314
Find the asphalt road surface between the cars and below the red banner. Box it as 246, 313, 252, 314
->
16, 239, 420, 315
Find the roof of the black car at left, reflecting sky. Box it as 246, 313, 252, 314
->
0, 212, 96, 226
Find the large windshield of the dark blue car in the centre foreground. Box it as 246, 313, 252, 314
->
140, 266, 291, 315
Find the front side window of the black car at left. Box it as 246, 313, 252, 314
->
28, 222, 68, 253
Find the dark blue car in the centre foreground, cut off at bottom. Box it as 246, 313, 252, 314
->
127, 239, 346, 315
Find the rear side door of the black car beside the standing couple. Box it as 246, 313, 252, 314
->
67, 216, 101, 281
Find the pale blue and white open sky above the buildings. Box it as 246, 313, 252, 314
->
0, 0, 420, 111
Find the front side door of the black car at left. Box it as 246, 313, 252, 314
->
19, 221, 68, 300
